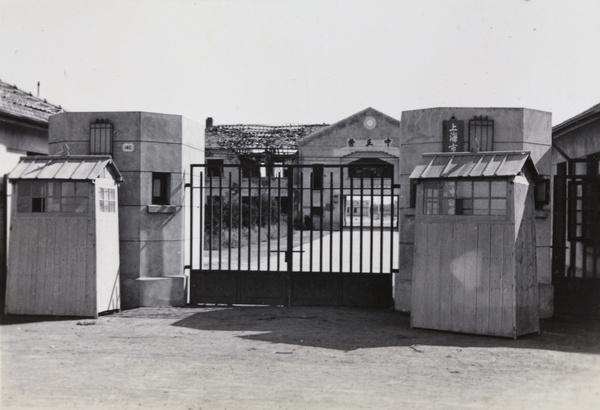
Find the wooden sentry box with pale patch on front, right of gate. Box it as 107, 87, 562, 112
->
410, 152, 539, 338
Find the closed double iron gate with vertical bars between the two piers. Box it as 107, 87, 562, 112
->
190, 163, 398, 308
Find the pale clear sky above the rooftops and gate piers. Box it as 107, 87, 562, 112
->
0, 0, 600, 125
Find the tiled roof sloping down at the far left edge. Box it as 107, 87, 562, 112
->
0, 81, 65, 122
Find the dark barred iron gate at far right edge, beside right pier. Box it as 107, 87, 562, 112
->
552, 159, 600, 317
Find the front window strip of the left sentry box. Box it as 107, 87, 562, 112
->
17, 181, 89, 213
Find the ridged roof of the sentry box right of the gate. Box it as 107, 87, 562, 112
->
410, 151, 537, 179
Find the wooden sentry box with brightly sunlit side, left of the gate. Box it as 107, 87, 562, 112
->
5, 156, 123, 317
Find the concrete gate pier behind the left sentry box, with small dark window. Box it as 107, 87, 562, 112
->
49, 112, 204, 309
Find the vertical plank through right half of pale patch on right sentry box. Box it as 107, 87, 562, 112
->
463, 222, 480, 333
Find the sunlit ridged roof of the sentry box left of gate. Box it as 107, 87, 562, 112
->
9, 155, 123, 182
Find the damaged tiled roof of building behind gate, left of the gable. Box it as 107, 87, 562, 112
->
206, 124, 328, 150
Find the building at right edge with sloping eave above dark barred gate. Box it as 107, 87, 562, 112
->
552, 104, 600, 317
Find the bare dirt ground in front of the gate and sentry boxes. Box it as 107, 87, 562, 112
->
0, 307, 600, 409
